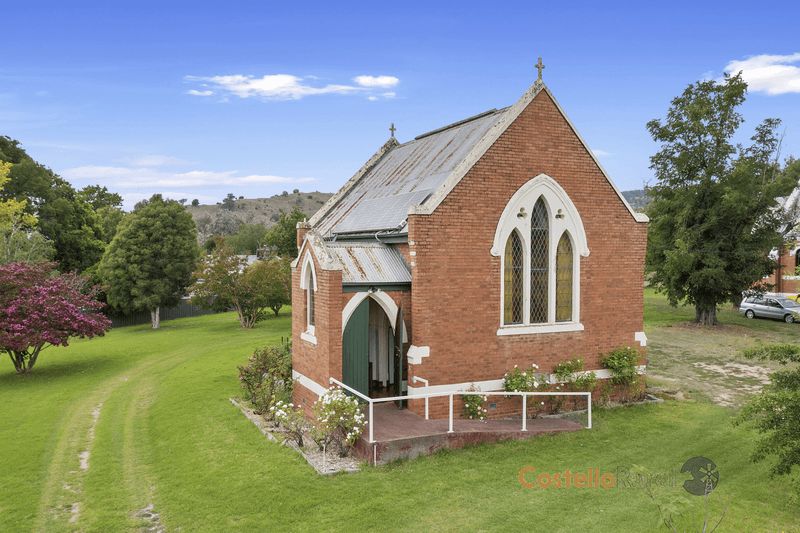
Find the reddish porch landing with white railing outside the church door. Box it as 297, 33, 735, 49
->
353, 403, 583, 465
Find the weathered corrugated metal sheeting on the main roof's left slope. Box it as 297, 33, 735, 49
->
315, 108, 508, 236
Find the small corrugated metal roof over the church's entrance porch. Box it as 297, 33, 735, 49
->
325, 242, 411, 283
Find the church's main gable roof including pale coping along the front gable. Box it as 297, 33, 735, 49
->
309, 80, 649, 238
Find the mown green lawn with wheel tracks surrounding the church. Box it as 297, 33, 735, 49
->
0, 306, 798, 533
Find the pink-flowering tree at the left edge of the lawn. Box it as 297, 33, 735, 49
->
0, 262, 111, 374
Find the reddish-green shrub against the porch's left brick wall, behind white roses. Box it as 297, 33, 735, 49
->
238, 338, 292, 416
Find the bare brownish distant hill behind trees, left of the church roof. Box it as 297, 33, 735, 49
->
186, 191, 333, 242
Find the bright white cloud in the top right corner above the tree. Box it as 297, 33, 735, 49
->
725, 53, 800, 94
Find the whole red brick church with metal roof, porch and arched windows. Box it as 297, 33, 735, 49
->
292, 63, 648, 418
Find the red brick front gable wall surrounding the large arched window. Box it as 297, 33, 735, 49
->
409, 91, 647, 416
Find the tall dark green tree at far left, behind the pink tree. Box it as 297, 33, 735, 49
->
0, 136, 105, 272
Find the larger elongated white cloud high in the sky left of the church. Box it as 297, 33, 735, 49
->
185, 74, 363, 100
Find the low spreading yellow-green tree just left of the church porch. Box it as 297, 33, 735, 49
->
189, 242, 292, 329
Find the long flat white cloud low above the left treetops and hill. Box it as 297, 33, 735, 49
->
60, 166, 314, 190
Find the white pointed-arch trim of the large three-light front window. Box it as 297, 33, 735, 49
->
491, 174, 589, 335
